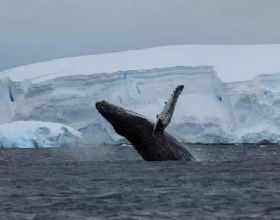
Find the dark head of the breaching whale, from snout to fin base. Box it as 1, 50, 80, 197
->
95, 101, 154, 143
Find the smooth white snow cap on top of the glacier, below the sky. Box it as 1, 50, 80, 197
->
1, 44, 280, 82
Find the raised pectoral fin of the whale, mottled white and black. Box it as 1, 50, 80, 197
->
153, 85, 184, 135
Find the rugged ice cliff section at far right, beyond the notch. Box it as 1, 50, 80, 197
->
226, 73, 280, 143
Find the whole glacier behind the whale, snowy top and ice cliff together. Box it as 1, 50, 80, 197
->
0, 45, 280, 145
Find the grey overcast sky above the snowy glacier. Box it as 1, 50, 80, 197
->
0, 0, 280, 70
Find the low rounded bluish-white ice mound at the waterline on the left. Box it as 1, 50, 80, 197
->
0, 121, 81, 148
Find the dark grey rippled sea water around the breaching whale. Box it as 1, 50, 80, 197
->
0, 145, 280, 220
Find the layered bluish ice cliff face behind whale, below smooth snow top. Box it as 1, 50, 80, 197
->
0, 66, 280, 145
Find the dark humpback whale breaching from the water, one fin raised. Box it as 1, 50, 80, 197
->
96, 85, 195, 161
